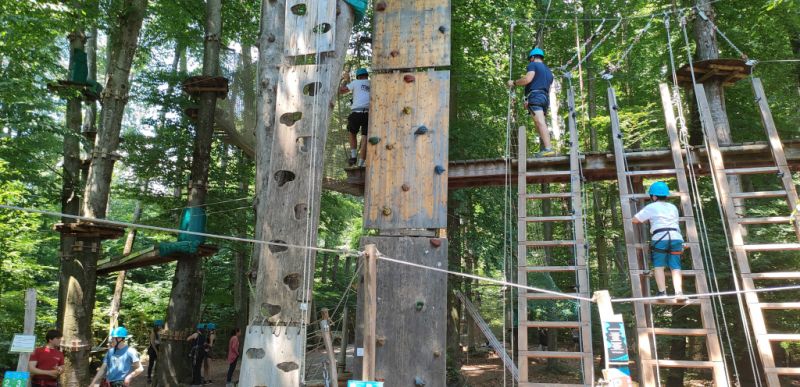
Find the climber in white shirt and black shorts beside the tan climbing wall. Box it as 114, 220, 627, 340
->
339, 68, 370, 167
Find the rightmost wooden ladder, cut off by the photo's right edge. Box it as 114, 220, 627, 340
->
694, 78, 800, 387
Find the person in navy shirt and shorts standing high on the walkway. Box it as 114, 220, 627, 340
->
508, 47, 556, 157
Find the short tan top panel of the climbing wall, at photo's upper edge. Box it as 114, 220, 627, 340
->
372, 0, 451, 69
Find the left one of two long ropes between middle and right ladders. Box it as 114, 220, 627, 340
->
664, 13, 741, 385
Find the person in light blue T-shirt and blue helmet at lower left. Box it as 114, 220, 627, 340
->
91, 327, 144, 387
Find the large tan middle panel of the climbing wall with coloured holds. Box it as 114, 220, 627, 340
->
364, 71, 450, 230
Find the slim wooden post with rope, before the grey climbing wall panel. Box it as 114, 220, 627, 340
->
361, 244, 378, 380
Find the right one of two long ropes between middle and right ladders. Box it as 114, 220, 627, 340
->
679, 13, 761, 386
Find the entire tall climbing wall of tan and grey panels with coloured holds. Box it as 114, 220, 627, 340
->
356, 0, 450, 387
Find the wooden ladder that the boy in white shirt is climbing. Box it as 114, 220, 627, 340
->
608, 84, 729, 387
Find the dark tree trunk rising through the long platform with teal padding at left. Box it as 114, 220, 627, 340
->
156, 0, 222, 386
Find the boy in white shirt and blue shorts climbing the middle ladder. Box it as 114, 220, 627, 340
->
633, 181, 685, 300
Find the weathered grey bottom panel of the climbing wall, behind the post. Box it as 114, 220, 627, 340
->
353, 237, 447, 387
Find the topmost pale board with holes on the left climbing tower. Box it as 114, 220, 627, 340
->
283, 0, 336, 56
